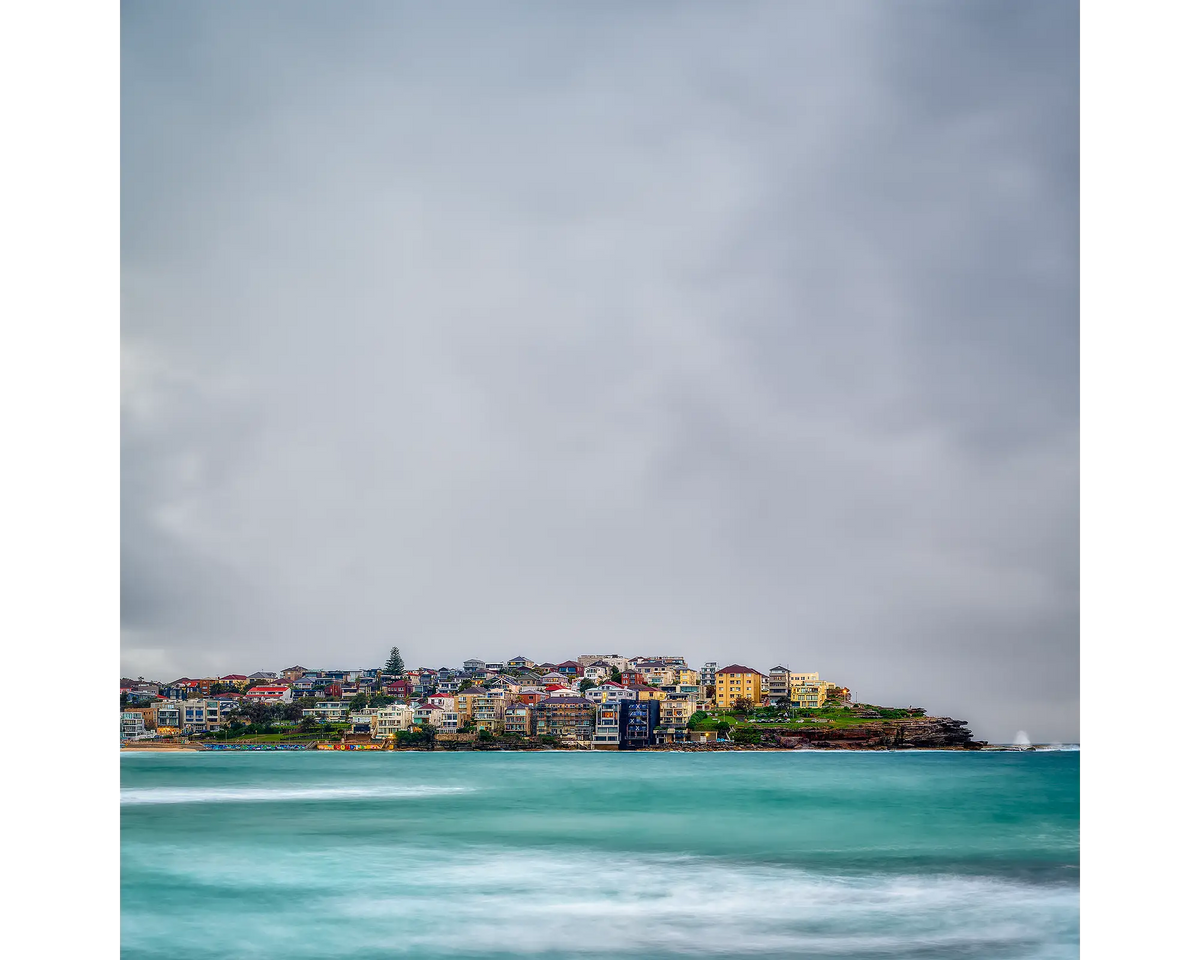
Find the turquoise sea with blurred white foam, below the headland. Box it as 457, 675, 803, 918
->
116, 750, 1084, 960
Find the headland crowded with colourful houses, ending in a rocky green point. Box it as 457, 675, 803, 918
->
116, 647, 986, 750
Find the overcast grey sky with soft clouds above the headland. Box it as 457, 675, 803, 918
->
116, 0, 1082, 743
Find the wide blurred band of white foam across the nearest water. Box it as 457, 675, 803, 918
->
130, 845, 1082, 960
